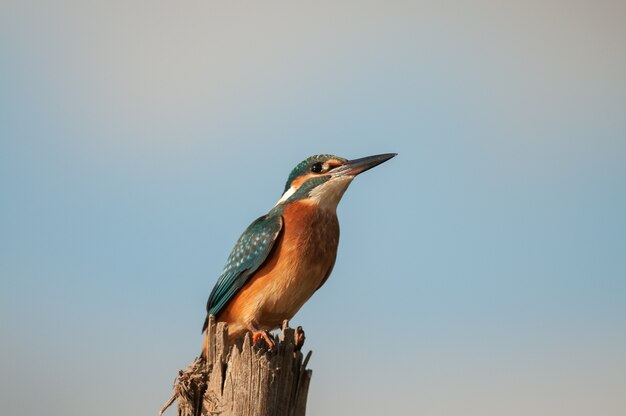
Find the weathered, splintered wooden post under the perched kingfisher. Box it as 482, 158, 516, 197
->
161, 316, 312, 416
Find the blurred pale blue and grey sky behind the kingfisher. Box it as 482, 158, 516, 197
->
0, 0, 626, 416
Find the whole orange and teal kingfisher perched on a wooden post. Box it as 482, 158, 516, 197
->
202, 153, 396, 358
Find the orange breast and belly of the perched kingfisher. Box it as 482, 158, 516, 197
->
218, 202, 339, 337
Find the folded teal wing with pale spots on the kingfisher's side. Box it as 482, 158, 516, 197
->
202, 213, 283, 331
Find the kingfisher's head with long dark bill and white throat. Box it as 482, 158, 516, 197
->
276, 153, 396, 210
